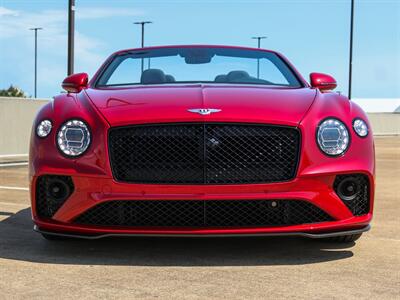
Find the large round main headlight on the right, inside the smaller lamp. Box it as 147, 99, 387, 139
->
317, 119, 350, 156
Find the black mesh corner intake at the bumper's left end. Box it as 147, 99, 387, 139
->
36, 175, 74, 218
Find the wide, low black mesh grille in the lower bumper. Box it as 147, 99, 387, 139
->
74, 200, 333, 227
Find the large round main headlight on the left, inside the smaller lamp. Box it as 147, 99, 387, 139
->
57, 120, 90, 156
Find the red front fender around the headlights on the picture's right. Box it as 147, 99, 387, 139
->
298, 92, 375, 177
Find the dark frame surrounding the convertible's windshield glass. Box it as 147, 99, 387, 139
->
89, 45, 309, 89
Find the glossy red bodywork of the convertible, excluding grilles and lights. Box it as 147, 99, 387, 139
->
29, 46, 375, 235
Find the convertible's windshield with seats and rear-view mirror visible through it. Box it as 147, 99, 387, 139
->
96, 47, 302, 87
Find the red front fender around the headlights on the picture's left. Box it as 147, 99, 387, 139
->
29, 92, 111, 177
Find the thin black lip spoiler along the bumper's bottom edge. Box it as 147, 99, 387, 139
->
33, 225, 371, 240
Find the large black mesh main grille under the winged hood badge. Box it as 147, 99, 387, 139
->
109, 123, 300, 184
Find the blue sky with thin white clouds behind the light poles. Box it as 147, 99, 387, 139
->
0, 0, 400, 98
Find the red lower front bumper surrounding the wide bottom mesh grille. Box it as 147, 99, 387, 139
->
31, 173, 373, 239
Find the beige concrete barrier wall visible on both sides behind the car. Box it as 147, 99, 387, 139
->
0, 97, 400, 157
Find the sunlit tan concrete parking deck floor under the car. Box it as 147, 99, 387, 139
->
0, 137, 400, 299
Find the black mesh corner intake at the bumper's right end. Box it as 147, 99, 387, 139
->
333, 174, 370, 216
